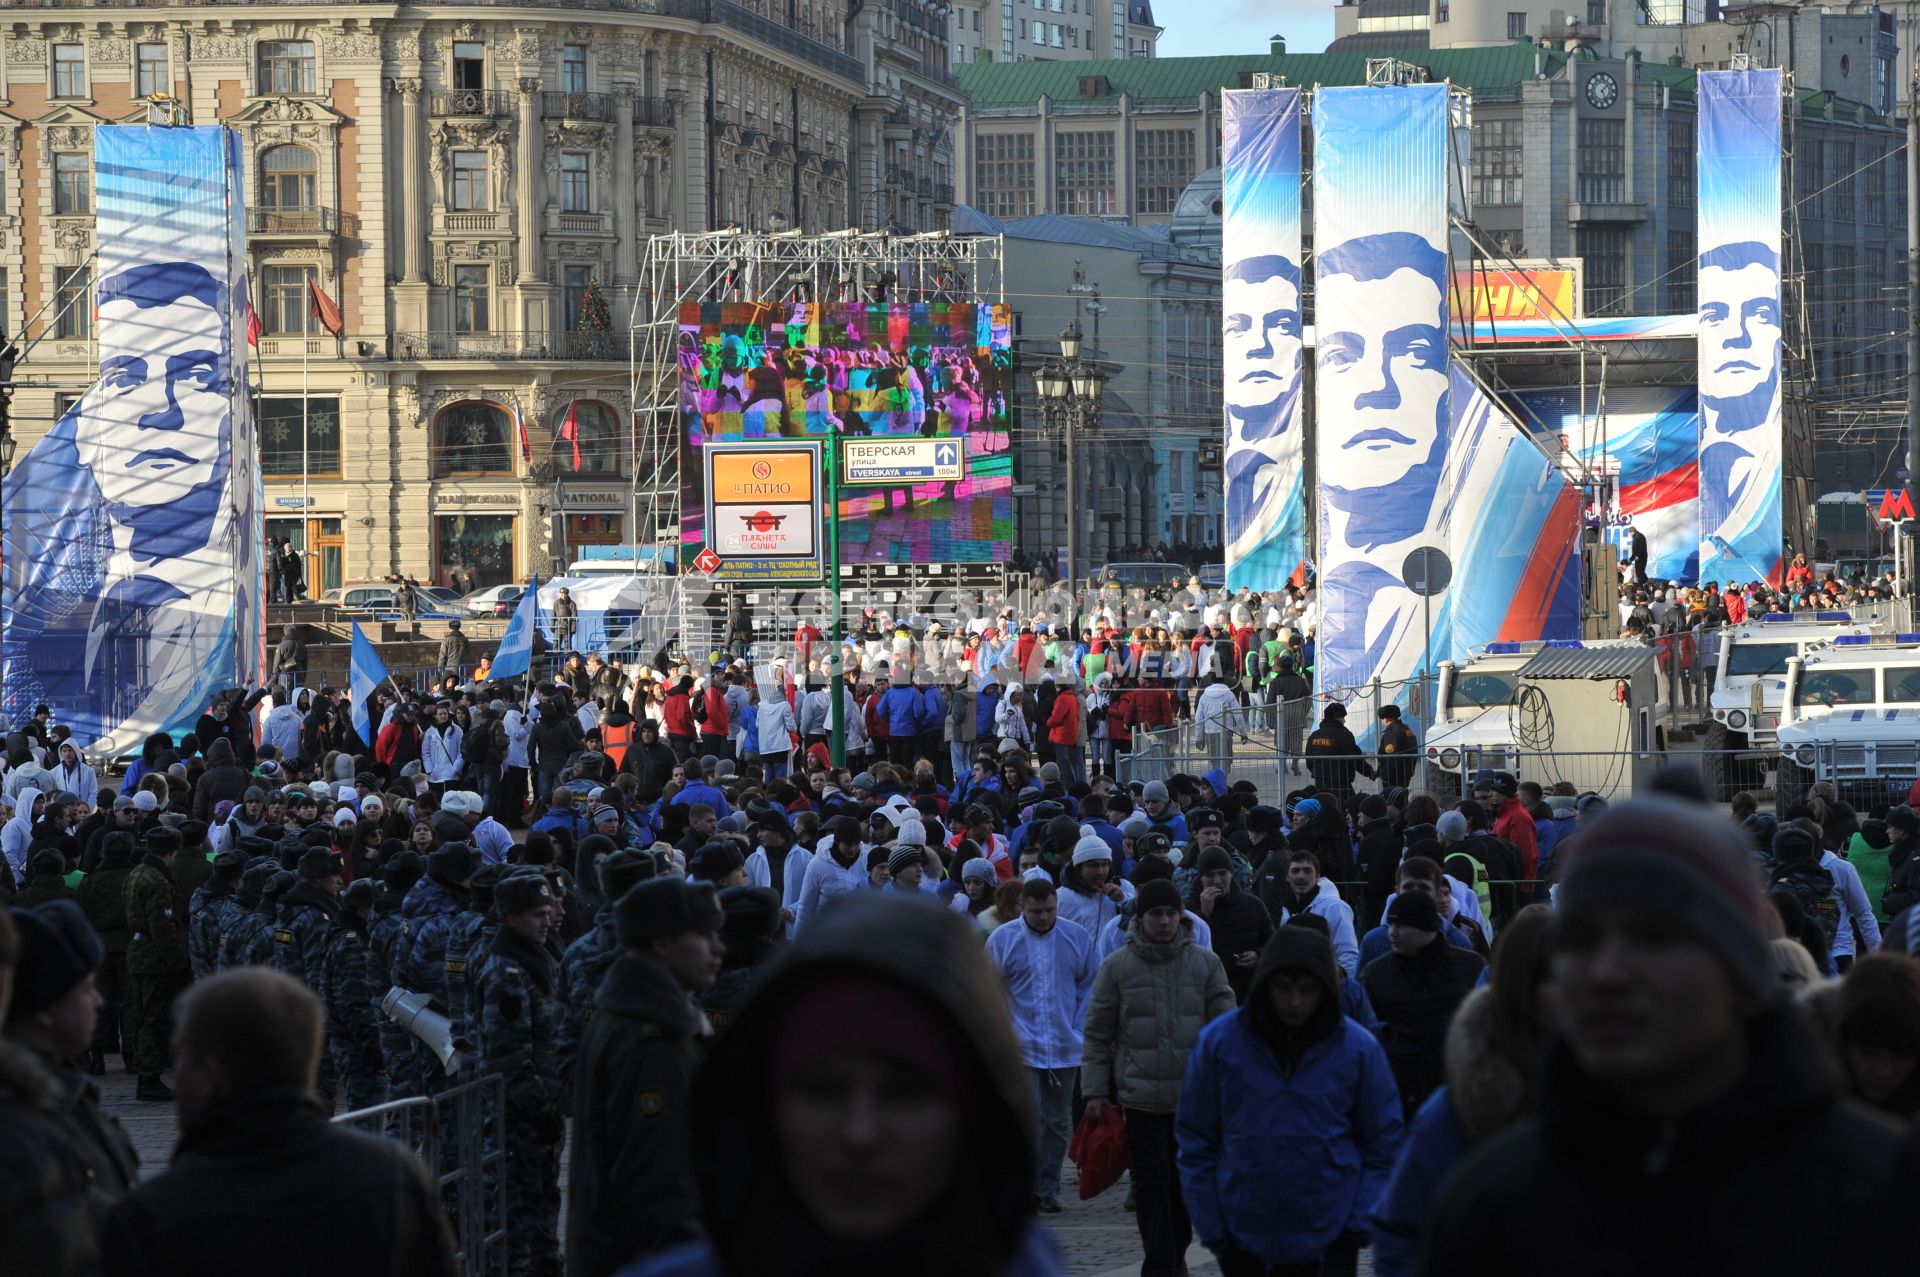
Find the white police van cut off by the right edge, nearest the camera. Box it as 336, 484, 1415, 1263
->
1774, 634, 1920, 814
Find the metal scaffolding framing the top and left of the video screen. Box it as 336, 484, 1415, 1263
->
628, 229, 1006, 657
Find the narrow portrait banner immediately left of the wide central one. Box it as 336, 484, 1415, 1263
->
1221, 88, 1308, 590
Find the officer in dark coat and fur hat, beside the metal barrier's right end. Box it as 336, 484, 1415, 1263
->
566, 876, 726, 1273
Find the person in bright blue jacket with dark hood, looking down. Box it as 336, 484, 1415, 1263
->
1175, 928, 1402, 1277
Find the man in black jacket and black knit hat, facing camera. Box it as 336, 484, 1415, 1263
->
1359, 875, 1484, 1120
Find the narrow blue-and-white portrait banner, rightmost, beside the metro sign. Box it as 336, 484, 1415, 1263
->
1697, 71, 1784, 584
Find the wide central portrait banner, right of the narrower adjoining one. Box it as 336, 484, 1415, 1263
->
1313, 84, 1452, 701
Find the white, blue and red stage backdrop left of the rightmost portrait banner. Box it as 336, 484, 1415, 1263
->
1515, 386, 1699, 586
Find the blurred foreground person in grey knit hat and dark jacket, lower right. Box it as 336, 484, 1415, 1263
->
1425, 799, 1916, 1277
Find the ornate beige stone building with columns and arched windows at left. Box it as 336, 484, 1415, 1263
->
0, 0, 958, 593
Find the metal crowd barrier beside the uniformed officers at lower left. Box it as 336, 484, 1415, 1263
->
334, 1073, 507, 1277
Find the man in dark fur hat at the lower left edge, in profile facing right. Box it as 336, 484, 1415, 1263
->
0, 901, 140, 1190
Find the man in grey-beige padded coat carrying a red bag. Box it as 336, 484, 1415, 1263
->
1081, 878, 1235, 1277
